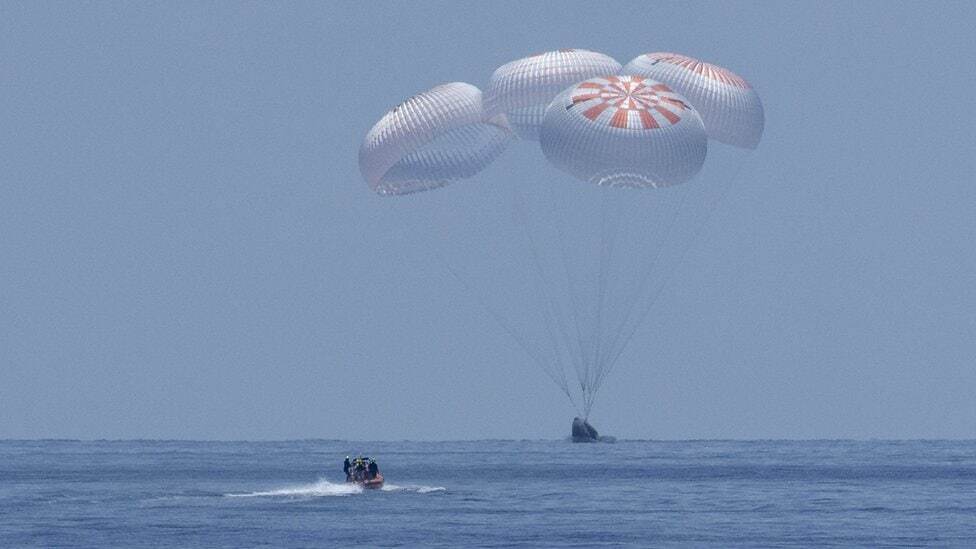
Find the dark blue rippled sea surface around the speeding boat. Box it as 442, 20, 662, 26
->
0, 441, 976, 547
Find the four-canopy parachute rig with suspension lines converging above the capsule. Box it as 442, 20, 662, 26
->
359, 49, 764, 420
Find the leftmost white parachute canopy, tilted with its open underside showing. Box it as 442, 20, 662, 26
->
359, 82, 512, 195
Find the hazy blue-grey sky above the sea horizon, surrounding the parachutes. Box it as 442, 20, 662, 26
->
0, 1, 976, 440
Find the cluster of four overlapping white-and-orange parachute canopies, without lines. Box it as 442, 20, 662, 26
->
359, 49, 764, 195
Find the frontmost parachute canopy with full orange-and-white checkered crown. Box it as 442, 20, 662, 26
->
539, 76, 708, 187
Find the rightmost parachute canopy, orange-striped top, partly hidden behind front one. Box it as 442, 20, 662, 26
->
623, 52, 765, 149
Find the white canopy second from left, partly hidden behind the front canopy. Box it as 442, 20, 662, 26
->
485, 49, 620, 141
